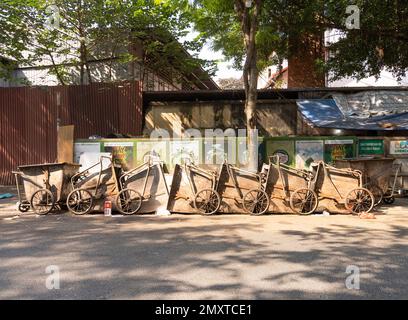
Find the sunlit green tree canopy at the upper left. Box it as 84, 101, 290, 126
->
0, 0, 215, 84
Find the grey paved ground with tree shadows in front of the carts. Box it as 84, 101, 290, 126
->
0, 188, 408, 299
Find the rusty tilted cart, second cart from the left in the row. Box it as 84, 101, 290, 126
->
67, 156, 120, 215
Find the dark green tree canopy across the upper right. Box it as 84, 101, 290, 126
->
184, 0, 408, 79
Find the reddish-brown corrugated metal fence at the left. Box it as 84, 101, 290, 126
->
0, 82, 143, 185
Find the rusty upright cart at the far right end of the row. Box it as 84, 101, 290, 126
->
334, 158, 399, 205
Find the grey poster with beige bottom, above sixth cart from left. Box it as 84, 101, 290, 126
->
296, 140, 323, 170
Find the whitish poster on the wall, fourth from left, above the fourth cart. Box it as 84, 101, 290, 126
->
169, 140, 200, 166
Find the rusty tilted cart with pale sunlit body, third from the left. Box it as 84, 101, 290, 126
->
115, 155, 169, 215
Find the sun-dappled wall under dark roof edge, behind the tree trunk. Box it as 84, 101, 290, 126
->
144, 101, 297, 136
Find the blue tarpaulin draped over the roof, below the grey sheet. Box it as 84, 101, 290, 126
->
297, 99, 408, 130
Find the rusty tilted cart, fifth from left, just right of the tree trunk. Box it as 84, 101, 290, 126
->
218, 161, 269, 215
